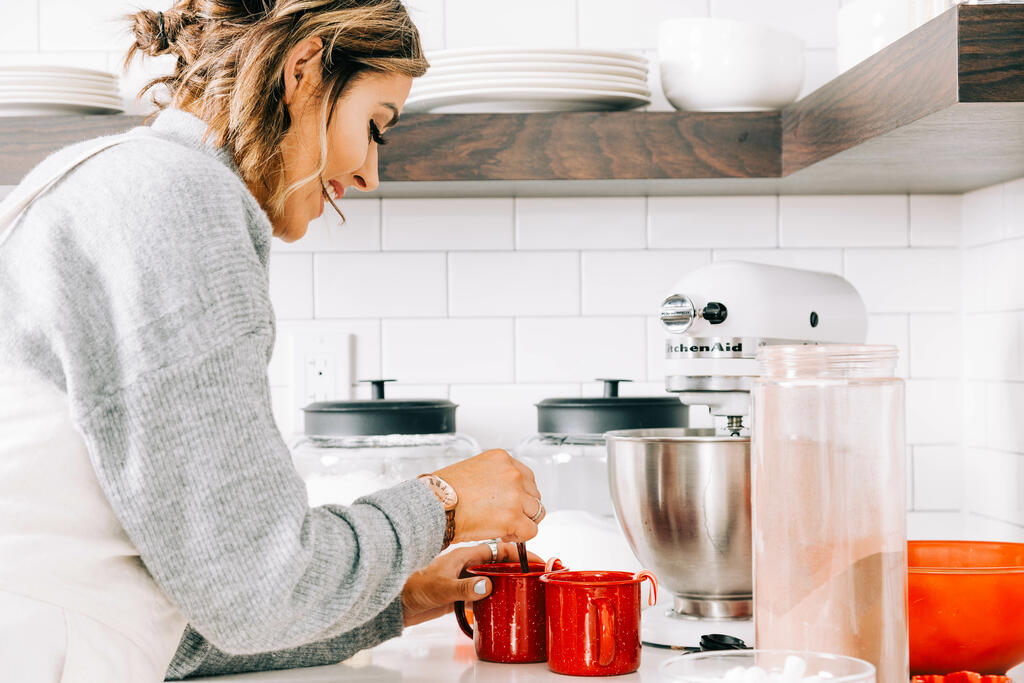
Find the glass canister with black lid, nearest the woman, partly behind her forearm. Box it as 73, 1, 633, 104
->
292, 380, 479, 506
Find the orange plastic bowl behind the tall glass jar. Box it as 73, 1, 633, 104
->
907, 541, 1024, 674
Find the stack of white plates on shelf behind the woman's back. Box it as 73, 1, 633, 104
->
0, 66, 124, 116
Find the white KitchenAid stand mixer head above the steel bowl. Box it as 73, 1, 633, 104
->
660, 261, 867, 434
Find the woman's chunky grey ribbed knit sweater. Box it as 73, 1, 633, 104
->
0, 111, 444, 678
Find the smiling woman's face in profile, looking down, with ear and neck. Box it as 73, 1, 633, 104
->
272, 38, 413, 242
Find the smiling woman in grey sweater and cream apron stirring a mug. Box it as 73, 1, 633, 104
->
0, 0, 544, 683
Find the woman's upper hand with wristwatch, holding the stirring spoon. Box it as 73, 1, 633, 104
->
434, 450, 544, 543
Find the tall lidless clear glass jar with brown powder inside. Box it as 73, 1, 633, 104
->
752, 344, 909, 683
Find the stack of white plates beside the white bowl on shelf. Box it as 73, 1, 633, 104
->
406, 48, 650, 114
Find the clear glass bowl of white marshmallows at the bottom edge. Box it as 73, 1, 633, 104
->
657, 650, 874, 683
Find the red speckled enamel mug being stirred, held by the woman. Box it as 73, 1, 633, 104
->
455, 558, 561, 664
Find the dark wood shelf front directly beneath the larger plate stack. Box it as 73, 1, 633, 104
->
380, 112, 781, 180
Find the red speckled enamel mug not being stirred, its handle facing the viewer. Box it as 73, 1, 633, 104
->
541, 570, 657, 676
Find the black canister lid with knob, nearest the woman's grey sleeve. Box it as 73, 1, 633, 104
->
302, 380, 458, 436
